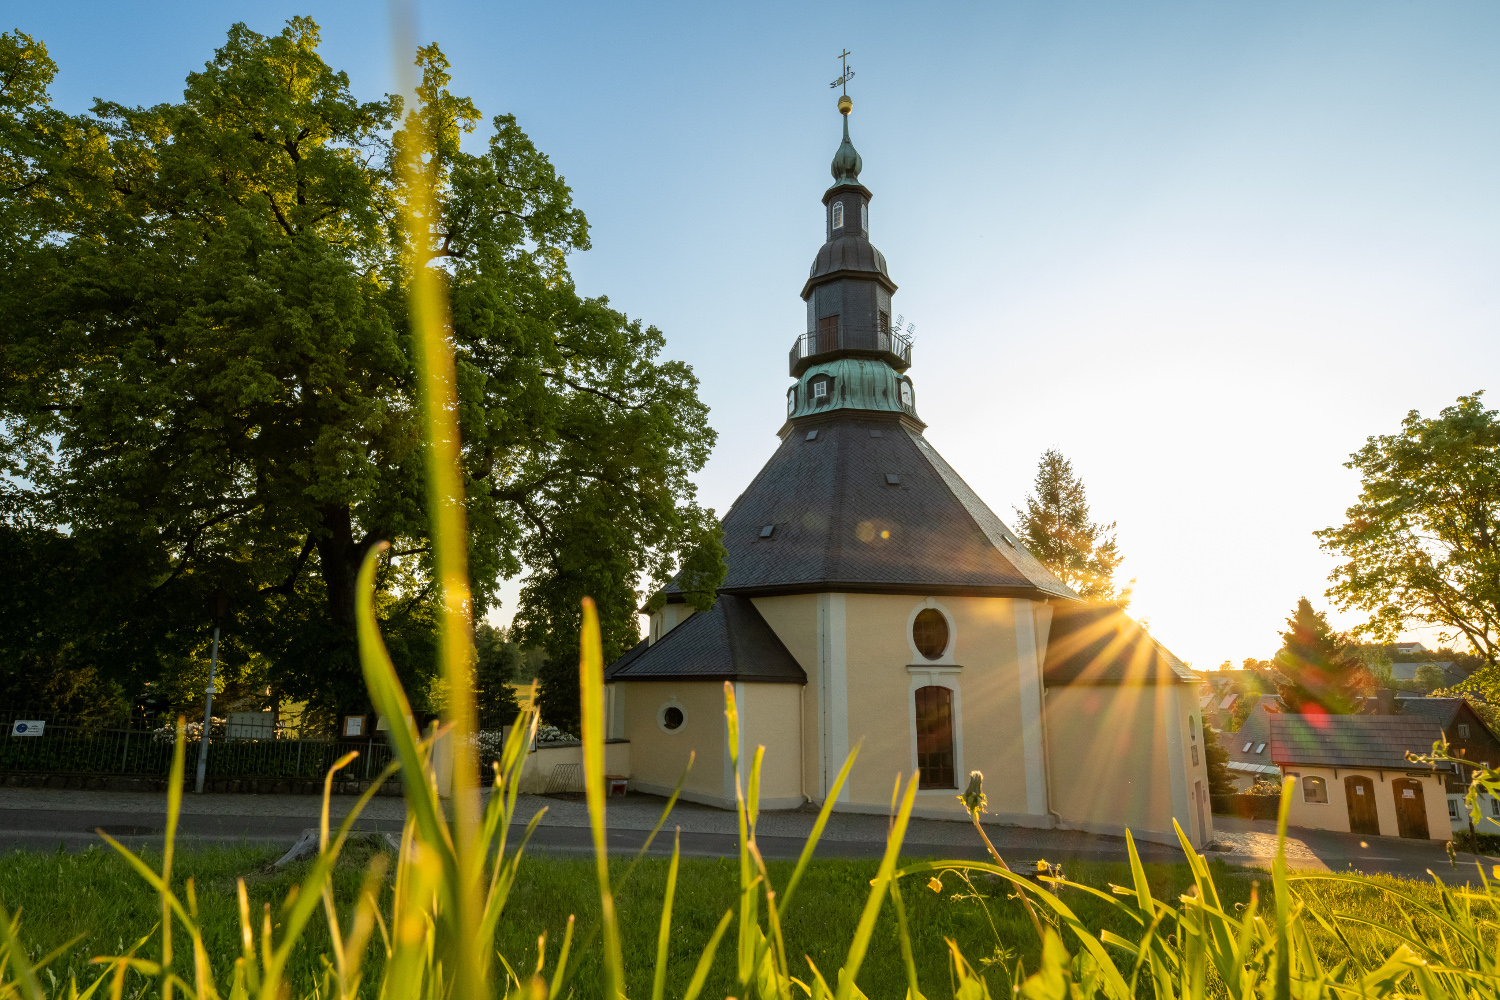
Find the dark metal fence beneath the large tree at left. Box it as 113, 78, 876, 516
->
0, 712, 392, 781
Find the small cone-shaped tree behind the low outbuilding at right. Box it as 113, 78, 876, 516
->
1275, 597, 1374, 715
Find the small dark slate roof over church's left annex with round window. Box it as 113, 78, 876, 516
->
605, 594, 807, 684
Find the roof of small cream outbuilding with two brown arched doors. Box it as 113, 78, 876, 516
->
1271, 712, 1452, 771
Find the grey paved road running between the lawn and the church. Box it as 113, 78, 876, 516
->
0, 789, 1500, 880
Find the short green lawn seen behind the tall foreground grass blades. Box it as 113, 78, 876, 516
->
0, 841, 1464, 997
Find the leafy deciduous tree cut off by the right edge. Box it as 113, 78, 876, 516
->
1316, 391, 1500, 667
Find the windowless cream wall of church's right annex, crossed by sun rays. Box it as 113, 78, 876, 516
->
1047, 685, 1214, 846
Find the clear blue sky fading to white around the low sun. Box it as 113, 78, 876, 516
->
14, 0, 1500, 669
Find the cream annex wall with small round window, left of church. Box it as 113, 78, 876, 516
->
609, 681, 726, 804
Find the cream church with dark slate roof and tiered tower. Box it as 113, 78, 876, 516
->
605, 96, 1214, 849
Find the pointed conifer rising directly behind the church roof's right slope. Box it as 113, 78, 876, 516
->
1016, 448, 1136, 607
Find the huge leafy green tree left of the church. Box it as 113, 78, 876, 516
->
0, 18, 717, 728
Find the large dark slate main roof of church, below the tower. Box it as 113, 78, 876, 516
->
690, 411, 1076, 600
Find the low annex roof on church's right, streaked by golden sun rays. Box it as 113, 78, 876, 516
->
1043, 603, 1199, 687
